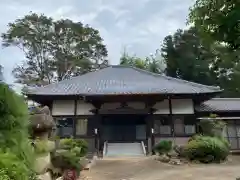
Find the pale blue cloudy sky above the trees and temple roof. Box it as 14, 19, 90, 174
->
0, 0, 194, 90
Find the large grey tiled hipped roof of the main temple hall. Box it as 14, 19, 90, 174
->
28, 66, 221, 96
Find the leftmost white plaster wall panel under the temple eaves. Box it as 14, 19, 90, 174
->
52, 100, 74, 116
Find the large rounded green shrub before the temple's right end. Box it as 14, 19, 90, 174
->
184, 136, 229, 163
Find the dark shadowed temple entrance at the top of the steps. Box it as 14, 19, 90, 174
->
101, 114, 146, 142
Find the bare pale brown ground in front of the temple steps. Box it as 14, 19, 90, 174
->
81, 157, 240, 180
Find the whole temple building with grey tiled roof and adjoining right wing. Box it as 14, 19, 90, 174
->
27, 66, 240, 155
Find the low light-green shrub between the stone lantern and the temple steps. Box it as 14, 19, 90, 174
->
59, 138, 88, 157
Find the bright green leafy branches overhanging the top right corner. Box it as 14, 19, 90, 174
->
189, 0, 240, 49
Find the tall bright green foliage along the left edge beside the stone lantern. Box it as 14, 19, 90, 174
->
0, 84, 34, 179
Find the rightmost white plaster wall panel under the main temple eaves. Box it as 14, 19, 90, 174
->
171, 99, 194, 114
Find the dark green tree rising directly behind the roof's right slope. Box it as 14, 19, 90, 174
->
161, 28, 213, 84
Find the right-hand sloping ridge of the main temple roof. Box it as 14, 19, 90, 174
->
116, 65, 221, 91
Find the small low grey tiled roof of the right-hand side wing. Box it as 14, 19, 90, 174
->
196, 98, 240, 112
